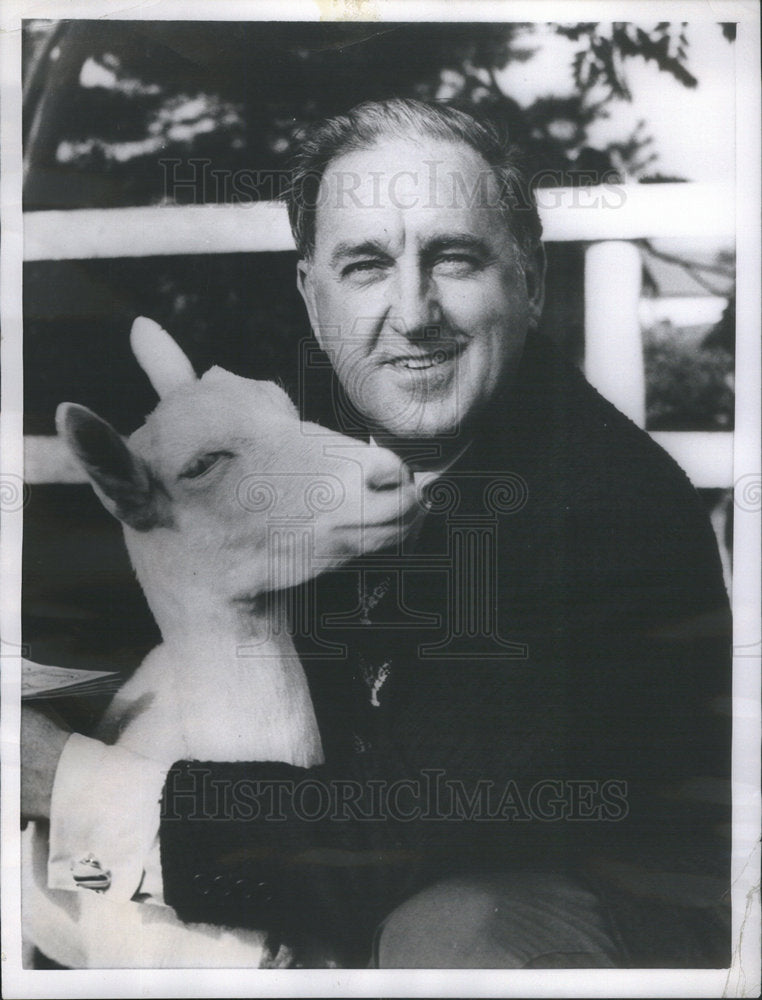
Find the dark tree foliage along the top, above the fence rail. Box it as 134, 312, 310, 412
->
24, 20, 729, 207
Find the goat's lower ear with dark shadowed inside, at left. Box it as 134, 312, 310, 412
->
56, 403, 158, 531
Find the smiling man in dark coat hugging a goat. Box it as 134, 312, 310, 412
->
19, 101, 729, 968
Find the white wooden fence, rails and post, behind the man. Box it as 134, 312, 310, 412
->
24, 184, 735, 487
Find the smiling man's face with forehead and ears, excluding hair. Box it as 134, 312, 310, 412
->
298, 137, 542, 439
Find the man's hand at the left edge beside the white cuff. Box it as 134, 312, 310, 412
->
21, 705, 71, 820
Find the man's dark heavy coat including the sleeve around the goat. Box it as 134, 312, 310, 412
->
156, 340, 730, 967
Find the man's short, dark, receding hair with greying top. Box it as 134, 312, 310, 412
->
285, 98, 542, 260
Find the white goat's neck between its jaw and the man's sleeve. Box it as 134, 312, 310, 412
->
115, 548, 322, 767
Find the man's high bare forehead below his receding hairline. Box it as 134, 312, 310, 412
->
315, 136, 504, 253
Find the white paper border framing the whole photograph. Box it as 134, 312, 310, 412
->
0, 0, 762, 998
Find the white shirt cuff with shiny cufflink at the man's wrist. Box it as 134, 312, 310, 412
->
48, 733, 169, 902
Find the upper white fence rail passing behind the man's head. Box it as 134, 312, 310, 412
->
24, 184, 735, 260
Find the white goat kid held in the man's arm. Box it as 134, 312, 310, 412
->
23, 319, 417, 968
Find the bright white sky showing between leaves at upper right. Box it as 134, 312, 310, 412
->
500, 23, 735, 181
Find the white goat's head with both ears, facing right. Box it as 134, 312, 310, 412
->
56, 319, 418, 625
